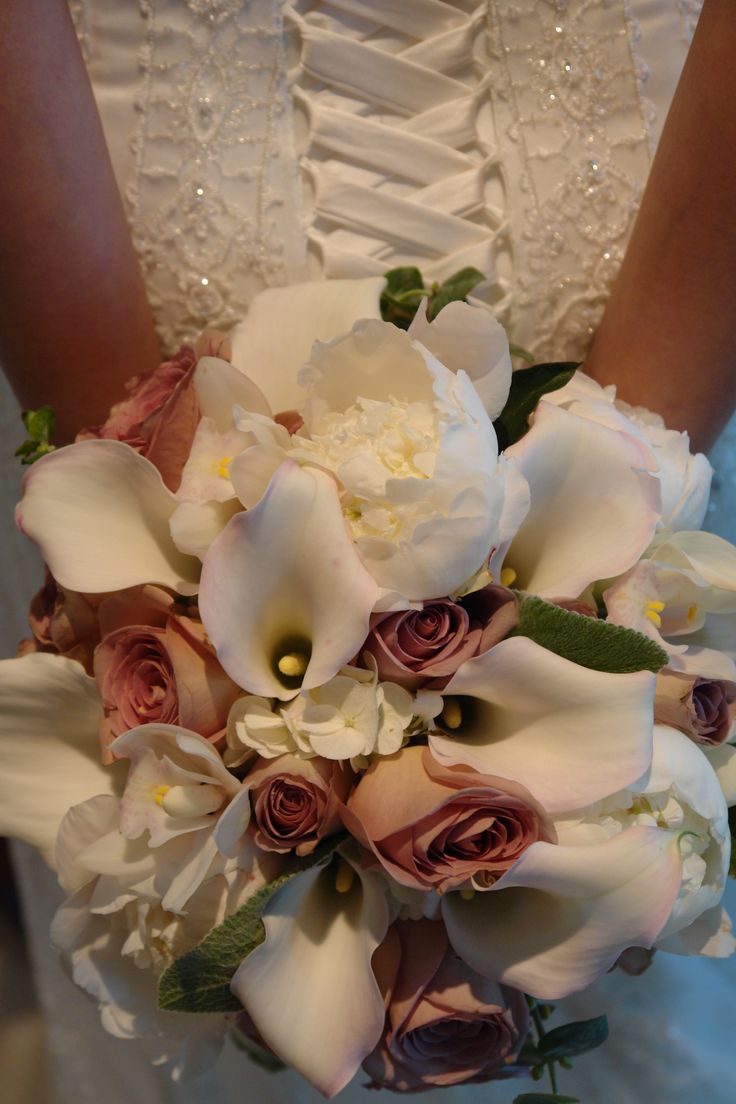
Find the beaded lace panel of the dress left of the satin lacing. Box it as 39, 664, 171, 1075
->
127, 0, 303, 349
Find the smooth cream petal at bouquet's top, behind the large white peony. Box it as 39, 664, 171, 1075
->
232, 276, 385, 411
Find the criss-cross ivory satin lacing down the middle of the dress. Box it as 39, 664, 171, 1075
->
285, 0, 506, 304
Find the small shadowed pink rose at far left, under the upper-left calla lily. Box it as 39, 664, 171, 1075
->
21, 570, 100, 673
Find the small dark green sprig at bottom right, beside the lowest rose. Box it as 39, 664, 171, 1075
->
513, 997, 608, 1104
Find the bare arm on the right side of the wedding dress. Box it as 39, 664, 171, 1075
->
586, 0, 736, 448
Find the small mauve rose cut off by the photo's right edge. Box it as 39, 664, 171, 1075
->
654, 671, 736, 746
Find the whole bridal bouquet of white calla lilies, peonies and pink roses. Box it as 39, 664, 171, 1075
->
0, 269, 736, 1102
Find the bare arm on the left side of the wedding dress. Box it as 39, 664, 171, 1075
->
0, 0, 159, 439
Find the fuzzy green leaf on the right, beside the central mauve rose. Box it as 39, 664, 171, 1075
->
511, 593, 668, 675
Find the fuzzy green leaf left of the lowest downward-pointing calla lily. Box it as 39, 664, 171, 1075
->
159, 835, 345, 1012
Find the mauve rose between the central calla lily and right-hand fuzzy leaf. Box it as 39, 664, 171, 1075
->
359, 585, 519, 690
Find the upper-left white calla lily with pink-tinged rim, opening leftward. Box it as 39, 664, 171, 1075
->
17, 440, 199, 594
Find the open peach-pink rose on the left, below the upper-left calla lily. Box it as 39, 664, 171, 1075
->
94, 587, 243, 762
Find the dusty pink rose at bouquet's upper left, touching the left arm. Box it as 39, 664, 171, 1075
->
76, 346, 199, 491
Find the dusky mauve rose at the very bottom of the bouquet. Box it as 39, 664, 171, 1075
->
363, 920, 529, 1093
